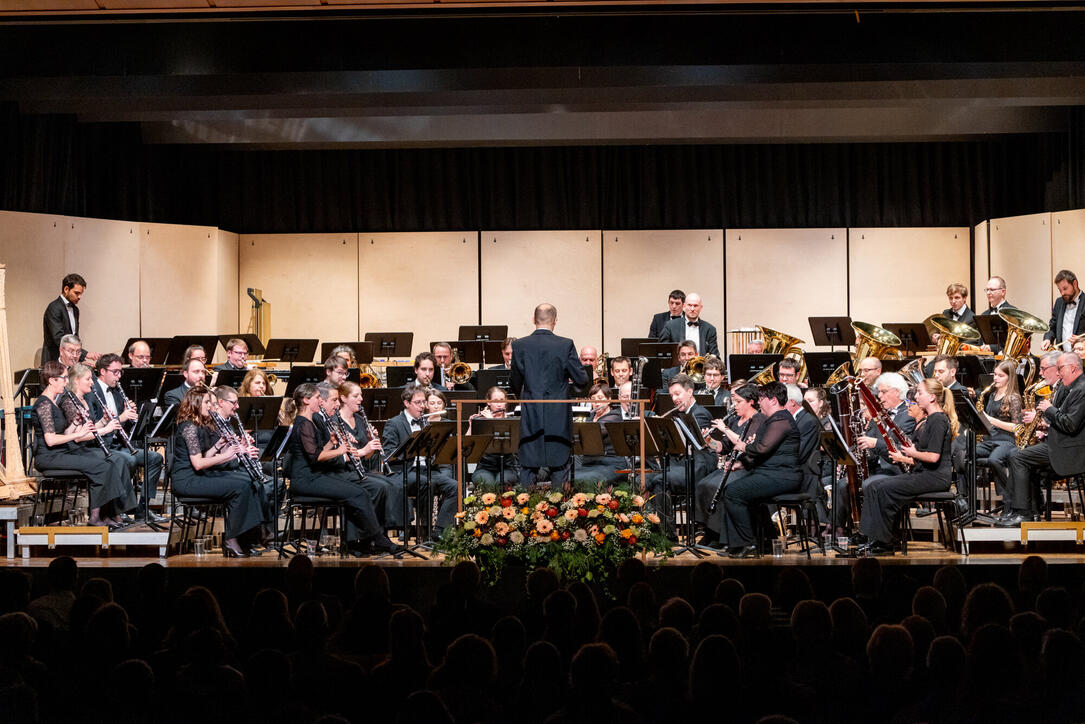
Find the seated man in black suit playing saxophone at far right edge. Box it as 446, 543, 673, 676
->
996, 352, 1085, 528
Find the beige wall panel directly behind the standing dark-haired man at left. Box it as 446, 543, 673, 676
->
64, 217, 140, 354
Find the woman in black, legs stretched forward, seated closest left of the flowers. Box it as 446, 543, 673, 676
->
286, 382, 394, 557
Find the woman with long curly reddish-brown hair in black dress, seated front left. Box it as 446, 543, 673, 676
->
173, 385, 264, 558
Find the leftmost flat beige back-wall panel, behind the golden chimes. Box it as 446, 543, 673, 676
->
235, 233, 358, 356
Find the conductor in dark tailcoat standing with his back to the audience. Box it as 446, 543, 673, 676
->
509, 304, 591, 487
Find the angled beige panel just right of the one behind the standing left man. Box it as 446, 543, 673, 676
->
139, 224, 235, 360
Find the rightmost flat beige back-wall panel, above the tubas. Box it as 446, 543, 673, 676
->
848, 227, 967, 325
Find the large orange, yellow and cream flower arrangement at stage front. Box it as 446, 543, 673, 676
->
437, 490, 671, 585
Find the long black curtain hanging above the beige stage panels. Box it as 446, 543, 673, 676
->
0, 105, 1067, 233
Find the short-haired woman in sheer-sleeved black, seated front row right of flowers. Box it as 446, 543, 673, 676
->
720, 382, 803, 558
